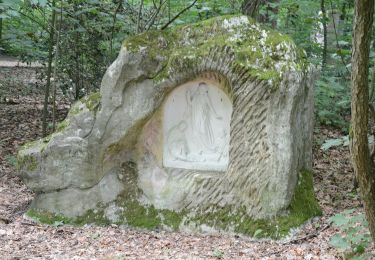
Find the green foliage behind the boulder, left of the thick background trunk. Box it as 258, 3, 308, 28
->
0, 0, 241, 99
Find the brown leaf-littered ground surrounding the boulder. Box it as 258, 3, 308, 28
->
0, 68, 375, 259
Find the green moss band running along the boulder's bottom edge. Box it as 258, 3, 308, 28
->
26, 171, 322, 239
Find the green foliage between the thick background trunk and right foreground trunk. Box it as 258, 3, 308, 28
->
242, 0, 356, 129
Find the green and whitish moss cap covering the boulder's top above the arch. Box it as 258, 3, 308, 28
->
124, 16, 308, 88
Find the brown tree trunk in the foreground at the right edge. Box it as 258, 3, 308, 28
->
351, 0, 375, 241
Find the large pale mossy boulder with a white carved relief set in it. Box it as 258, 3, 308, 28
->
18, 13, 320, 238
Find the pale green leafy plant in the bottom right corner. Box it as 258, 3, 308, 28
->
330, 209, 372, 258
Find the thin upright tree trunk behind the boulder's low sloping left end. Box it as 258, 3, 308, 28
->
42, 0, 56, 136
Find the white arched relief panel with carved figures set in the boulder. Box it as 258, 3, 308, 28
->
163, 81, 232, 171
